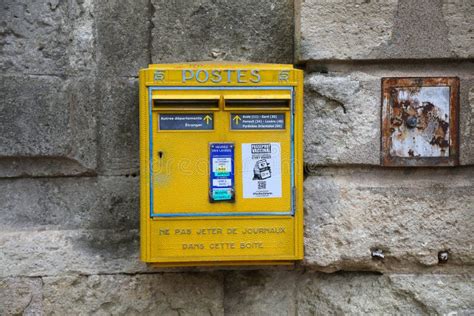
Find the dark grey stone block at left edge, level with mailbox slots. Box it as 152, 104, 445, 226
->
0, 76, 97, 177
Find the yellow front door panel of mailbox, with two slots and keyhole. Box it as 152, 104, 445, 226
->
150, 87, 294, 217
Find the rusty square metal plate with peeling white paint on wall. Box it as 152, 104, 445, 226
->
382, 77, 459, 167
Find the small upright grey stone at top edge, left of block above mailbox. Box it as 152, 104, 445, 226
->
95, 0, 152, 78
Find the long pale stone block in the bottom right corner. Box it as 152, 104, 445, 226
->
297, 273, 474, 315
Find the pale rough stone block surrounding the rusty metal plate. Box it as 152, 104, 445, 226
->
304, 62, 474, 166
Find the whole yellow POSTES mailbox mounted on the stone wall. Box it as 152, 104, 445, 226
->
139, 63, 303, 266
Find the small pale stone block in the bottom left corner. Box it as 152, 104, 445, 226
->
0, 278, 43, 316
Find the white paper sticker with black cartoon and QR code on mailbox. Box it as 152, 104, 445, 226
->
242, 143, 281, 199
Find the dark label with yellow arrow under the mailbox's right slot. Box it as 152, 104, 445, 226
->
230, 113, 285, 130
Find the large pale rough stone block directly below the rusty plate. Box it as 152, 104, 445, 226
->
304, 167, 474, 271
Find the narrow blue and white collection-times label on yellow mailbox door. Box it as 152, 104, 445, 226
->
209, 143, 235, 202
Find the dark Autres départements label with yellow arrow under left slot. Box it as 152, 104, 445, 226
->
159, 113, 214, 131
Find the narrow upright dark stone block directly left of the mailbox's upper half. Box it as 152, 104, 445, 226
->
98, 78, 139, 176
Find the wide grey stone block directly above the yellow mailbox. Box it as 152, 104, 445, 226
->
152, 0, 294, 63
